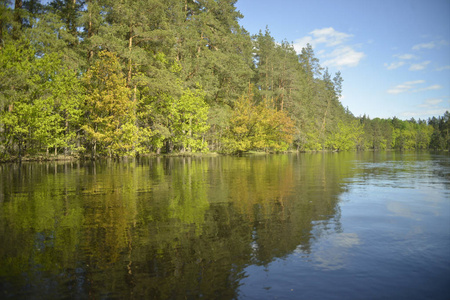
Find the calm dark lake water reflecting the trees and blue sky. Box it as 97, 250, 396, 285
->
0, 152, 450, 299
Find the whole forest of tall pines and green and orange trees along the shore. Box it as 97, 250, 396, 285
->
0, 0, 450, 161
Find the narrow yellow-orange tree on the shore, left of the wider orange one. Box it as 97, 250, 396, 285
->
82, 51, 138, 155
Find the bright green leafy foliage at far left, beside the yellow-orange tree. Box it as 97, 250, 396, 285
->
0, 41, 83, 156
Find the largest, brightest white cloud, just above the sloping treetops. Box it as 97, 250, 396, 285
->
294, 27, 365, 67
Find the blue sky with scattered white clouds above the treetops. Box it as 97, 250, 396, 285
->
236, 0, 450, 120
